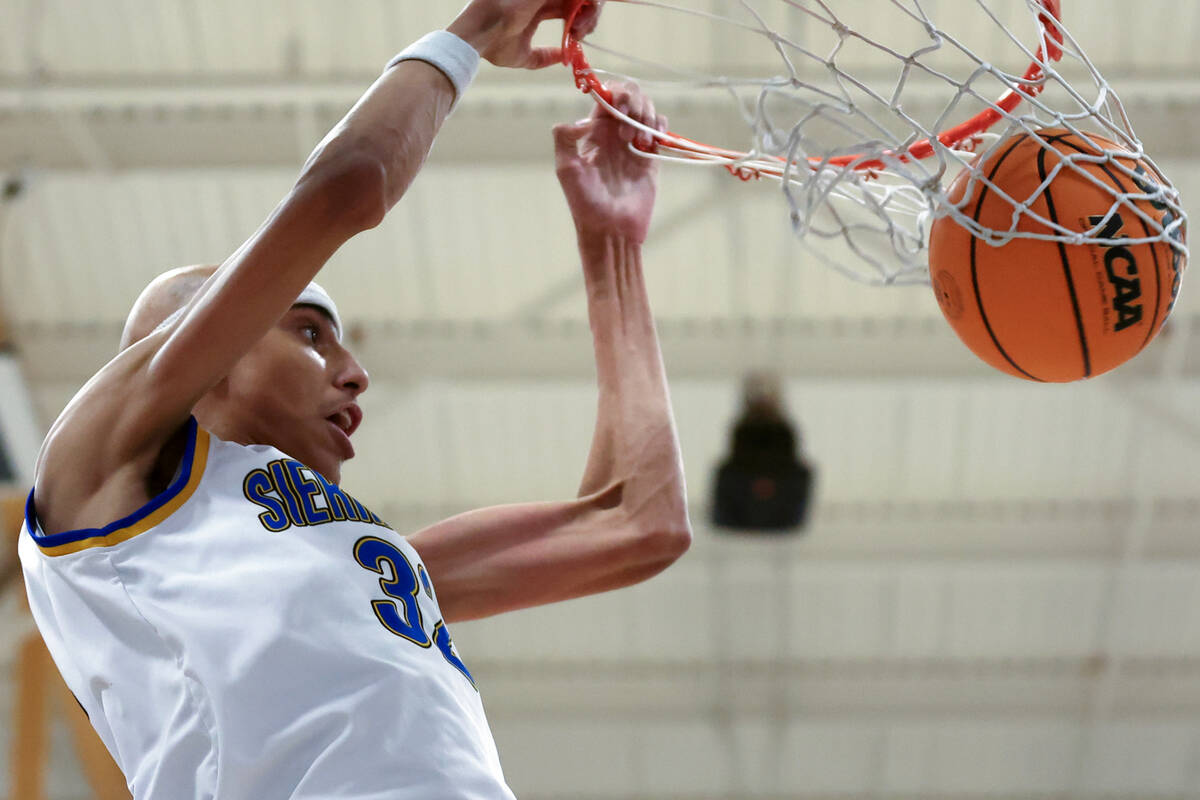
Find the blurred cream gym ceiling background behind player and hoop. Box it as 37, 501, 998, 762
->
0, 0, 1200, 800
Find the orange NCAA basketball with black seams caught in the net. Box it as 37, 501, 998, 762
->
929, 128, 1186, 381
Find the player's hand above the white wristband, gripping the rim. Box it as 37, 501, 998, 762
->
446, 0, 605, 70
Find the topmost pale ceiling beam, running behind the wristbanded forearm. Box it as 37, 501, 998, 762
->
7, 74, 1200, 170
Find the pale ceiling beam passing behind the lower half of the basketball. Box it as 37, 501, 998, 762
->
14, 317, 1200, 386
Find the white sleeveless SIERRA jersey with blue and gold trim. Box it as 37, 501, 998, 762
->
20, 420, 512, 800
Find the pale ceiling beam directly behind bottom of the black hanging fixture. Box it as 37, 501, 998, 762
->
376, 498, 1200, 563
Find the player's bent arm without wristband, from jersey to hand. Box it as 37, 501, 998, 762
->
409, 90, 691, 620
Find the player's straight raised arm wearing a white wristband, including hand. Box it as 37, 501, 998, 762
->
36, 0, 595, 533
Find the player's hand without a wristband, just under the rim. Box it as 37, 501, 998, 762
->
554, 84, 667, 243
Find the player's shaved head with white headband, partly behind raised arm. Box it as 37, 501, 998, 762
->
121, 266, 367, 482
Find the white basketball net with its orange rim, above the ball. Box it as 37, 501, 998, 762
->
564, 0, 1187, 284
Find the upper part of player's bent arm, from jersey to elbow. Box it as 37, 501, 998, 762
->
409, 486, 691, 621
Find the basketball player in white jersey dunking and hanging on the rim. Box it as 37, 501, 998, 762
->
20, 0, 690, 800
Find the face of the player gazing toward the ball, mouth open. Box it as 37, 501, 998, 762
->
214, 306, 367, 483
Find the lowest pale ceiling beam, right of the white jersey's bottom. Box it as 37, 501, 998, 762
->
472, 657, 1200, 719
